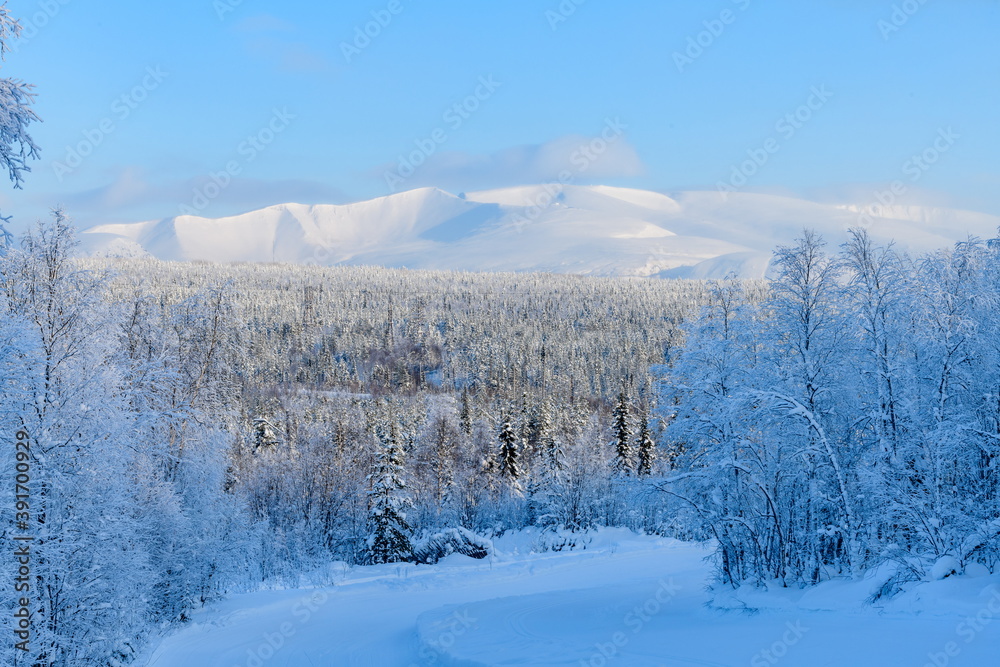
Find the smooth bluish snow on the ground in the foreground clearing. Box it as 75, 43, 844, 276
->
140, 530, 1000, 667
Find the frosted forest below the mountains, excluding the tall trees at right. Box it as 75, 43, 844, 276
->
0, 217, 705, 665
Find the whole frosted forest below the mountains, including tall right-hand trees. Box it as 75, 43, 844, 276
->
0, 212, 1000, 666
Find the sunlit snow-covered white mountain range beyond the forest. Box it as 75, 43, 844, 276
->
84, 185, 1000, 278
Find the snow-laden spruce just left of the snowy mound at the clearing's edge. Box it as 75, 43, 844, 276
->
368, 420, 412, 564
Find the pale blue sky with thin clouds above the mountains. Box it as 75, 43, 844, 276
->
0, 0, 1000, 229
